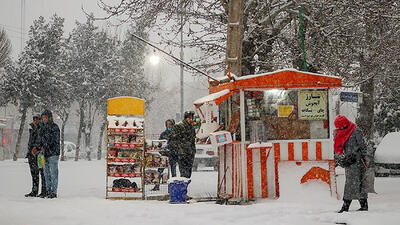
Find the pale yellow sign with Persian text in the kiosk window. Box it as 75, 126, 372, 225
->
299, 91, 328, 120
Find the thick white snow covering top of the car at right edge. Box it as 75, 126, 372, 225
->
375, 132, 400, 163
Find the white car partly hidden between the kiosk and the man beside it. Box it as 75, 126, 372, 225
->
193, 144, 218, 171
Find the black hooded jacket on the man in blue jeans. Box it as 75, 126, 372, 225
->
37, 120, 60, 158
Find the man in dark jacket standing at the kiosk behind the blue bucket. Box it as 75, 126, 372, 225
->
170, 111, 196, 178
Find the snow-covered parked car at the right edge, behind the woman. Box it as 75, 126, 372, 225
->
375, 132, 400, 177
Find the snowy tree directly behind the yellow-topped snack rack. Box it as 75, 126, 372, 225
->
97, 23, 154, 159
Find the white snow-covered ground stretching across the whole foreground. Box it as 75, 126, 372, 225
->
0, 160, 400, 225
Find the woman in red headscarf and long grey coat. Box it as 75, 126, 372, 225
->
334, 115, 373, 213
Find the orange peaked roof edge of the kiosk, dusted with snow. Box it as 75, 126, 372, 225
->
209, 69, 342, 93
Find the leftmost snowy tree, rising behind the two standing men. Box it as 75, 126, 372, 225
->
4, 15, 64, 160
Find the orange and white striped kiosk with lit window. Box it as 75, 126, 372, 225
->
195, 69, 342, 200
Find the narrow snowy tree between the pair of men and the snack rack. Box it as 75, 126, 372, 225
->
67, 17, 102, 161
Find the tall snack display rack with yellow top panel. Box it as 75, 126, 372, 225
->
106, 97, 145, 199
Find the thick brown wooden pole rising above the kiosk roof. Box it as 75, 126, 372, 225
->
225, 0, 243, 76
